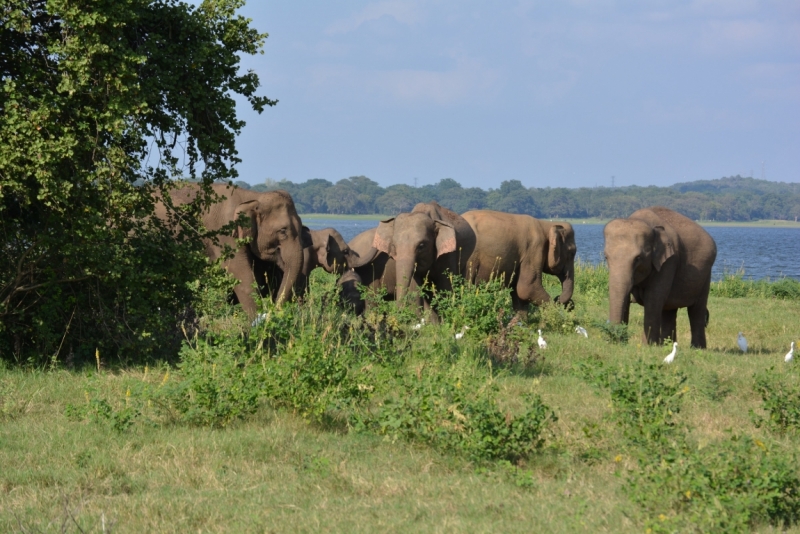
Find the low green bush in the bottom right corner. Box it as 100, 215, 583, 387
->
626, 436, 800, 533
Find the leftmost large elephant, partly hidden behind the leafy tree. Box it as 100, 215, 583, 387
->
156, 184, 303, 318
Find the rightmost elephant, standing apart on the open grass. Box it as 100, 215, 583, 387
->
603, 207, 717, 348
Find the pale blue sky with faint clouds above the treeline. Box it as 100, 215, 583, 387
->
228, 0, 800, 189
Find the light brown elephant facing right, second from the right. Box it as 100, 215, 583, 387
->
462, 210, 576, 313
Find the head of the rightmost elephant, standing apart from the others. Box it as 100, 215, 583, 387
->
603, 219, 675, 323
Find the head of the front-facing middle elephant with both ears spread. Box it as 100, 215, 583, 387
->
372, 213, 456, 302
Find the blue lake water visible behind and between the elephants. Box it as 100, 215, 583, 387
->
303, 219, 800, 280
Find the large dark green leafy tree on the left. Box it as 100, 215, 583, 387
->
0, 0, 275, 360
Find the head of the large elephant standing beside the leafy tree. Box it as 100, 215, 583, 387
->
234, 191, 303, 304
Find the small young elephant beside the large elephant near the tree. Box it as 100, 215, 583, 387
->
264, 226, 358, 298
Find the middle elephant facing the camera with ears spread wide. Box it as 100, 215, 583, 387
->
350, 201, 476, 314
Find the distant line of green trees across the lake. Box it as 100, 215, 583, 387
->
237, 176, 800, 221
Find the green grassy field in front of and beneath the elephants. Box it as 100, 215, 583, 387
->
0, 267, 800, 532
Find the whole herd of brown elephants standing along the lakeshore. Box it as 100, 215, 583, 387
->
156, 184, 716, 348
